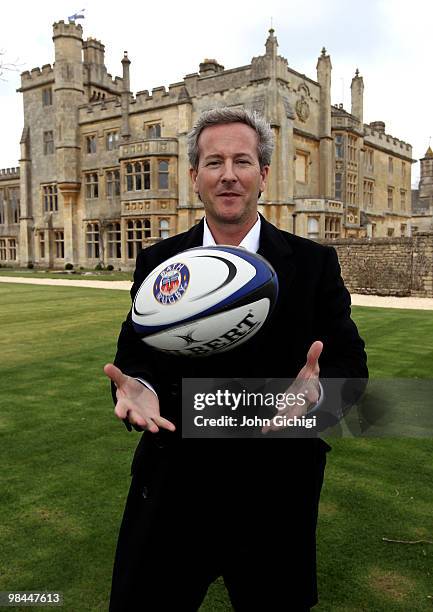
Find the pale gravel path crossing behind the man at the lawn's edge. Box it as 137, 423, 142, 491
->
0, 276, 433, 310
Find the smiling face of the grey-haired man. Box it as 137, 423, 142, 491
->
190, 123, 269, 225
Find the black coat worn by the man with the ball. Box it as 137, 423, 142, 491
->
111, 217, 368, 610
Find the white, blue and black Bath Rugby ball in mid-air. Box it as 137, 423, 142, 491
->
132, 245, 278, 357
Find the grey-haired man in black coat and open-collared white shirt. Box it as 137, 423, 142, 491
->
105, 109, 367, 612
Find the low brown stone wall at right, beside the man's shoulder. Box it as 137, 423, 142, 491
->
325, 232, 433, 297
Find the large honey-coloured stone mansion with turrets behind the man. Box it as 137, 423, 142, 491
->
0, 21, 412, 269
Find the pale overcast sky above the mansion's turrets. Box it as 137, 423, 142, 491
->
0, 0, 433, 182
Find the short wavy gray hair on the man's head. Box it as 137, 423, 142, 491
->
188, 107, 274, 170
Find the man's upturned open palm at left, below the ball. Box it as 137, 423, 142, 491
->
104, 363, 176, 433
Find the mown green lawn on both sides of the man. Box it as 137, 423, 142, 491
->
0, 283, 433, 612
